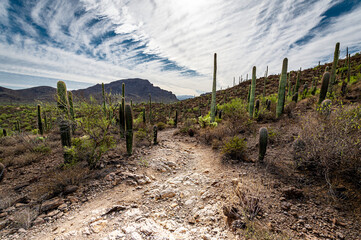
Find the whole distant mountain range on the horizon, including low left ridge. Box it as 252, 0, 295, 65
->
0, 78, 178, 103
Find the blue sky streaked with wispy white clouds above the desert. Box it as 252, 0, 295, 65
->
0, 0, 361, 95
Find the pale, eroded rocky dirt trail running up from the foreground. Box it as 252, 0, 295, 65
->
21, 130, 237, 240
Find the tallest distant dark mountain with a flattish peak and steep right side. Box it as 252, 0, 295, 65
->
73, 78, 178, 103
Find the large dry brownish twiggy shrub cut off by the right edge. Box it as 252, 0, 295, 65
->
298, 105, 361, 183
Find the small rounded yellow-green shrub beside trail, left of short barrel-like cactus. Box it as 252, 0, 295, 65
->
222, 136, 247, 160
